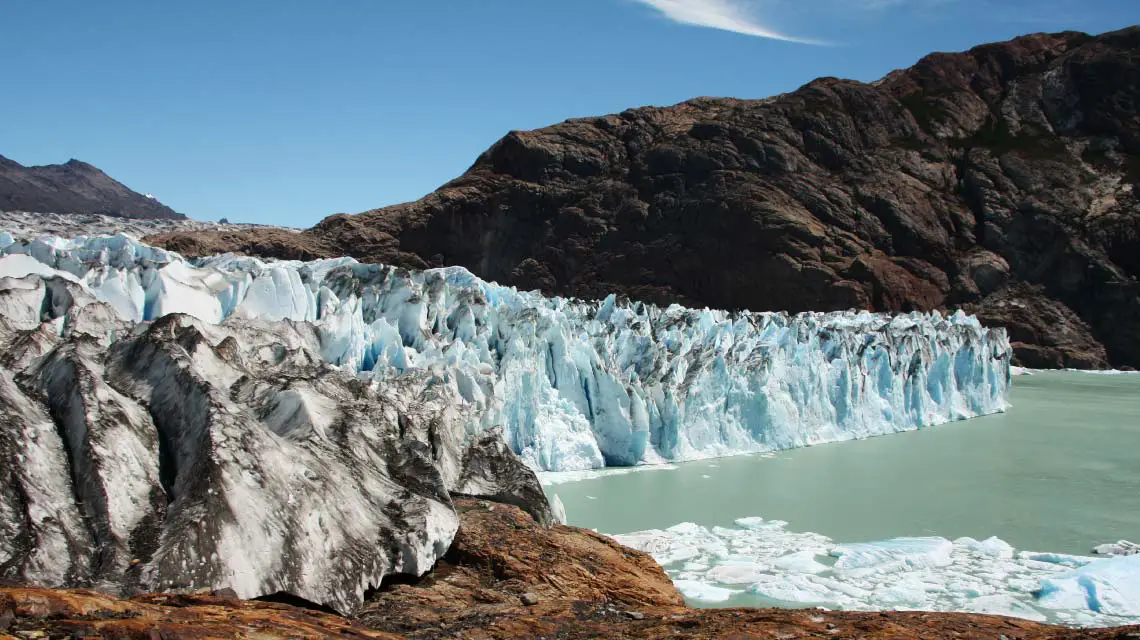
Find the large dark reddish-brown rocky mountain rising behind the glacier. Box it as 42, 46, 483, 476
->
150, 27, 1140, 368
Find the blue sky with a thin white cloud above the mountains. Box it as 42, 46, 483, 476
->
0, 0, 1140, 226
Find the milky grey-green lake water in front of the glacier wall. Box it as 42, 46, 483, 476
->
546, 372, 1140, 624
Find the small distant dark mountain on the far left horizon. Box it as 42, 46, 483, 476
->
0, 155, 186, 219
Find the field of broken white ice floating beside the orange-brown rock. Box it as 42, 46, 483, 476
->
612, 518, 1140, 626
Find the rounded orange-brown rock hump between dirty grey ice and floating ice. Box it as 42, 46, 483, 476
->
359, 500, 684, 637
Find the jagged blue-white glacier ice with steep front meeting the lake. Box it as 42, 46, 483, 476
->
0, 233, 1010, 471
